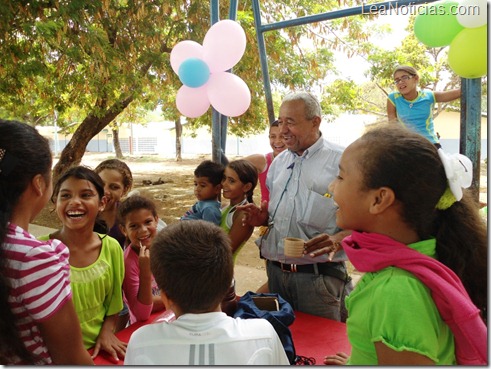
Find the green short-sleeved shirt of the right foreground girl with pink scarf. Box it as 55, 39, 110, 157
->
346, 239, 456, 365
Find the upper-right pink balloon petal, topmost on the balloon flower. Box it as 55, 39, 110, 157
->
203, 19, 246, 73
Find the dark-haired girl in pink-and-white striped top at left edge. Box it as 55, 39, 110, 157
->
0, 119, 94, 365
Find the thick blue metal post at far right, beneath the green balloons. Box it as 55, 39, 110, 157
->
459, 78, 481, 200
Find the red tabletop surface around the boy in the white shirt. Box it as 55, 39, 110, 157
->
89, 311, 351, 365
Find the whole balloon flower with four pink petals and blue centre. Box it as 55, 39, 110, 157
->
170, 20, 251, 118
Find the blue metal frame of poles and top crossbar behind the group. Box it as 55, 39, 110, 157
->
211, 0, 481, 197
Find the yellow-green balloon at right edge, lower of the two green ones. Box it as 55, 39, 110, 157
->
448, 26, 488, 78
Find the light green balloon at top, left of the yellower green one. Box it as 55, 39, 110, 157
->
414, 1, 464, 47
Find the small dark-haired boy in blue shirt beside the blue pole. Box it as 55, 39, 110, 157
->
181, 160, 225, 225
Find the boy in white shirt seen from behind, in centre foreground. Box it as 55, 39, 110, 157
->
125, 220, 289, 365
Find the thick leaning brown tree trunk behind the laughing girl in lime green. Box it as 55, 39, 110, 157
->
53, 96, 133, 183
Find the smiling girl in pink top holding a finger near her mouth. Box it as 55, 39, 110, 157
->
118, 195, 165, 324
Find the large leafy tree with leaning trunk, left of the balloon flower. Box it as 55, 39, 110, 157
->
0, 0, 191, 175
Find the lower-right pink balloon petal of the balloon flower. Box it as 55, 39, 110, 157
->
206, 72, 251, 117
